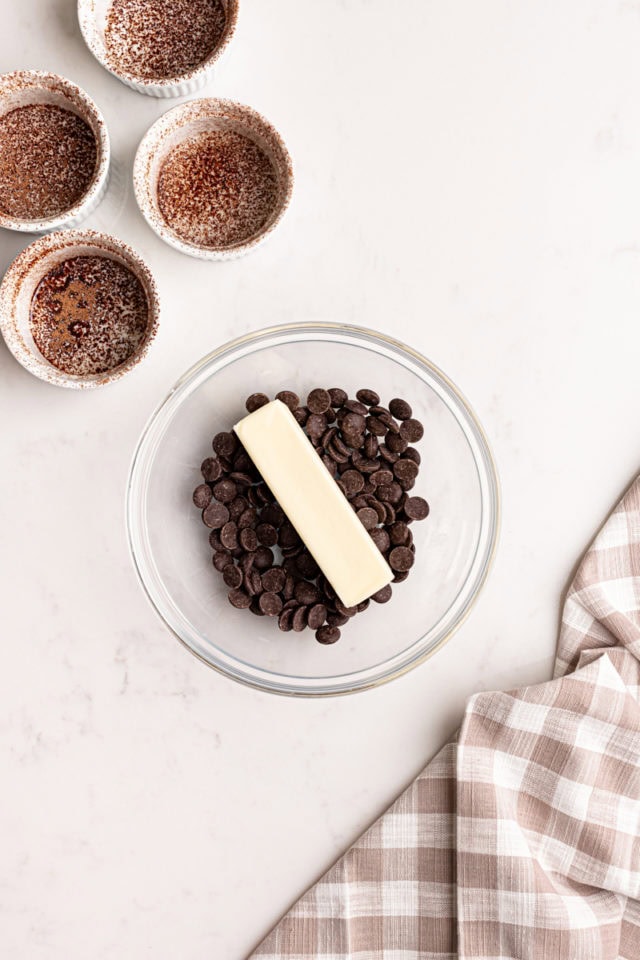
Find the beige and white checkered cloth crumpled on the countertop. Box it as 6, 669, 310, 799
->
248, 478, 640, 960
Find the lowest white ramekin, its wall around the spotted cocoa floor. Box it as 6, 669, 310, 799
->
0, 230, 160, 390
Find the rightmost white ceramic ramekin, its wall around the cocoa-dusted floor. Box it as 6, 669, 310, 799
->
133, 98, 293, 260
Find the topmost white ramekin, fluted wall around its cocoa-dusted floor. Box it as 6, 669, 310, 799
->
78, 0, 238, 97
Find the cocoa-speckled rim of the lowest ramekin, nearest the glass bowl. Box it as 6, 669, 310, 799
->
0, 227, 160, 390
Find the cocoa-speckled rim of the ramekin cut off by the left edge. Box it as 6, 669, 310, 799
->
0, 70, 111, 234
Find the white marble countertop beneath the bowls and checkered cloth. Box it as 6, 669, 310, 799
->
0, 0, 640, 960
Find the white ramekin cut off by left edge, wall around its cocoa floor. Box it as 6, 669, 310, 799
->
0, 70, 111, 233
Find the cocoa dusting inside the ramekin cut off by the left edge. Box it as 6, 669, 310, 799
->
0, 103, 98, 220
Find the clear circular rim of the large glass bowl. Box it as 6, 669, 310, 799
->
125, 321, 501, 699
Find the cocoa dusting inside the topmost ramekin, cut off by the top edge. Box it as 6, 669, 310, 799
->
104, 0, 226, 80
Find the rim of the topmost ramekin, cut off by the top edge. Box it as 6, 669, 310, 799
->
77, 0, 240, 96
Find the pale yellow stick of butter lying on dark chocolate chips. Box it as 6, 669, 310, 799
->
233, 400, 393, 607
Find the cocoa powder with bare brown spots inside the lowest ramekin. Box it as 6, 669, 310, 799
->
30, 256, 149, 377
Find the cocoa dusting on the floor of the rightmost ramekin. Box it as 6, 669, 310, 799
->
158, 130, 278, 248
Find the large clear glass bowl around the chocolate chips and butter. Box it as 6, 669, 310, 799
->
127, 323, 499, 696
